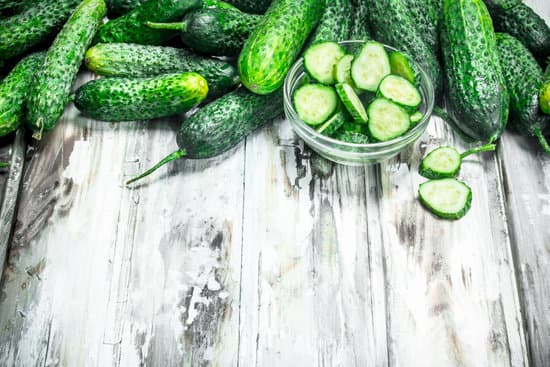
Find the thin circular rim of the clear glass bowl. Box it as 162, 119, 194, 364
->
283, 40, 435, 148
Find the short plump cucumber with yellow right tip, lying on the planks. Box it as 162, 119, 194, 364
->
74, 73, 208, 122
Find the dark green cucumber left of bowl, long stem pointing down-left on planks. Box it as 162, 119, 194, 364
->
127, 88, 283, 184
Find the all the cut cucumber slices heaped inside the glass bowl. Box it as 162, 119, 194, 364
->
293, 41, 423, 144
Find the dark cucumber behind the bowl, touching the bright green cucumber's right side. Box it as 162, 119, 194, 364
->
311, 0, 353, 44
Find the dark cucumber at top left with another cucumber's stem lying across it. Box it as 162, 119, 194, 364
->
94, 0, 202, 45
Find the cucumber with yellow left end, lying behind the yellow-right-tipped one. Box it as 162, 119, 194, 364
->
84, 43, 239, 96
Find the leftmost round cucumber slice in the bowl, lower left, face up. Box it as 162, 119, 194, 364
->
293, 84, 338, 125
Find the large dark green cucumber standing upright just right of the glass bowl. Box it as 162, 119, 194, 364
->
441, 0, 510, 141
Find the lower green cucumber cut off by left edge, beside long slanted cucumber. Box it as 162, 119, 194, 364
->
0, 53, 44, 137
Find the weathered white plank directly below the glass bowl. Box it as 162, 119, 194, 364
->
239, 121, 387, 366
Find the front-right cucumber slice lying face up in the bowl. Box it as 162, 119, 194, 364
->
367, 98, 411, 141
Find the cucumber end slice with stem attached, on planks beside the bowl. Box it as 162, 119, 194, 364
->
418, 144, 496, 179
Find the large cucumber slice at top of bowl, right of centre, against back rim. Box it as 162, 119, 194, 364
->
351, 41, 391, 92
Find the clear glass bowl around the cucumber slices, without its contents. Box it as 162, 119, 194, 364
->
284, 41, 434, 166
